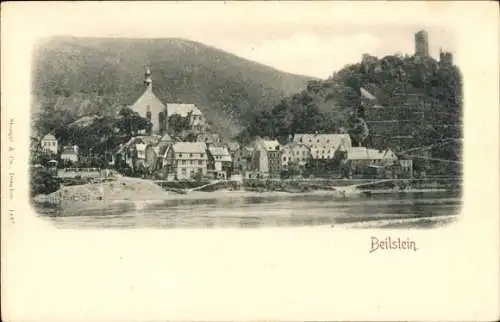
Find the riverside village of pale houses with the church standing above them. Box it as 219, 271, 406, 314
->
34, 69, 413, 186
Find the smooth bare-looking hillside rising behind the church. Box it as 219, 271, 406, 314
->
32, 37, 312, 137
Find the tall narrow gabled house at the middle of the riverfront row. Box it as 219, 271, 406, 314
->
250, 138, 281, 178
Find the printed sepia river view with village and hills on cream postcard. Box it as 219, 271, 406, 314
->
30, 15, 463, 229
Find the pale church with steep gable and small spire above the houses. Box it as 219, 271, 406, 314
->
129, 68, 205, 135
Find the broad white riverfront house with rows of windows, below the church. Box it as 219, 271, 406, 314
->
163, 142, 208, 180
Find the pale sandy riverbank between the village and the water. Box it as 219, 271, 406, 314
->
32, 177, 460, 215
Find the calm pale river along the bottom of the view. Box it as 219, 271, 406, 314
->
38, 193, 461, 229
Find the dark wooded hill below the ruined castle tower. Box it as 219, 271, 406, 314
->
239, 55, 462, 157
